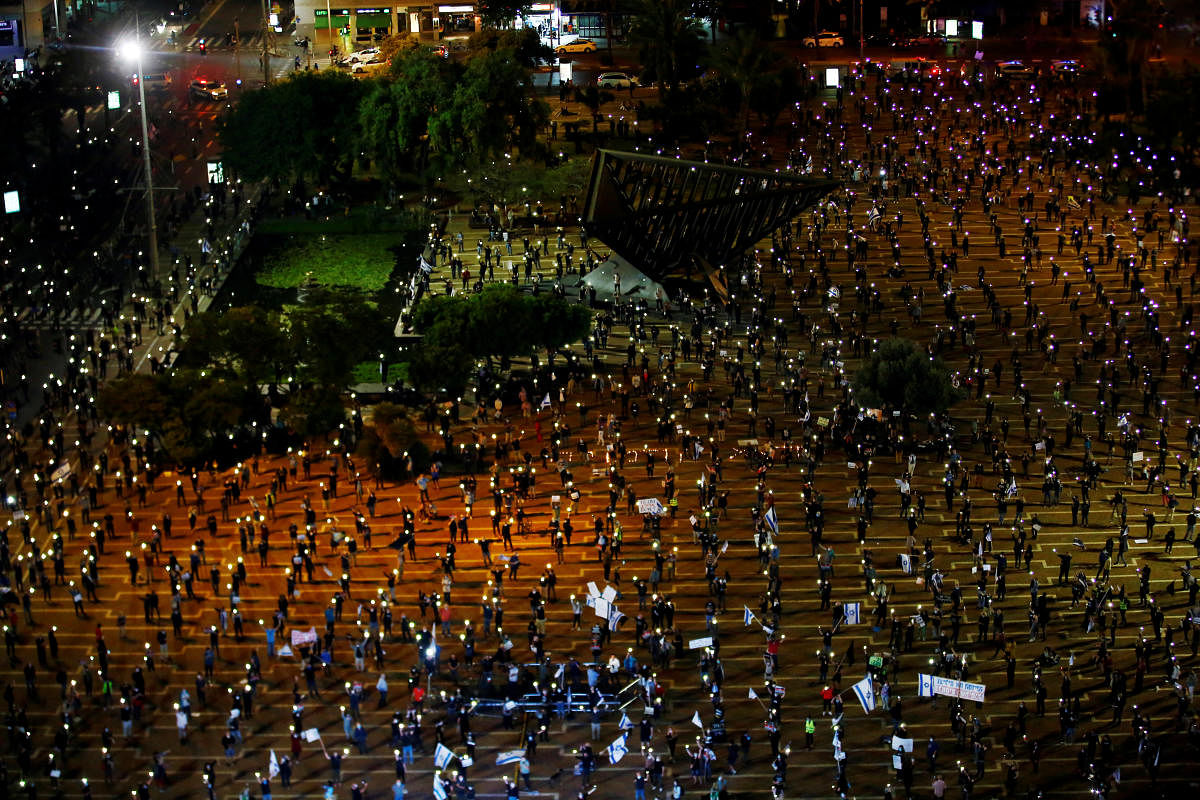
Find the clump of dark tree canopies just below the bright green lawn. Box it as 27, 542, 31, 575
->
100, 289, 392, 461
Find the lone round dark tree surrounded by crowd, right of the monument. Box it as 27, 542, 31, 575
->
852, 338, 961, 414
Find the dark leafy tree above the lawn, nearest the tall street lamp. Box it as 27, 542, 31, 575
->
217, 70, 364, 184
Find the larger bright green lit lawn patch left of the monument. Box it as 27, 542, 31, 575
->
254, 233, 404, 291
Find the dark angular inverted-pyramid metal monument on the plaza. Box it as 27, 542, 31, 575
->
583, 150, 840, 299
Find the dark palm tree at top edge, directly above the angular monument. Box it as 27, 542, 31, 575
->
630, 0, 706, 97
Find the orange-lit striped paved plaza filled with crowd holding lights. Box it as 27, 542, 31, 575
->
4, 64, 1200, 800
